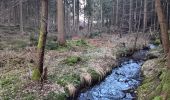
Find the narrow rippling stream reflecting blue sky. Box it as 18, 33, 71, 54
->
78, 45, 155, 100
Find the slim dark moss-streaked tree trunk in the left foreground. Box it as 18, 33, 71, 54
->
35, 0, 48, 81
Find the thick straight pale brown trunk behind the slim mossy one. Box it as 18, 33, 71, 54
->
57, 0, 66, 45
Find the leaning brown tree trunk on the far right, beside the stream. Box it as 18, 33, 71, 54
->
155, 0, 170, 54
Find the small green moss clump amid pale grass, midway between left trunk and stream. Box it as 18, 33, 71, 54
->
64, 56, 82, 66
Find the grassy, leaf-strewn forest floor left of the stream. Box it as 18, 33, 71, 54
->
0, 27, 149, 100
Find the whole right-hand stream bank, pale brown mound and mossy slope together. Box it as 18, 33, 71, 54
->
137, 46, 170, 100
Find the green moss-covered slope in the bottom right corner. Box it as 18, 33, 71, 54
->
138, 58, 170, 100
